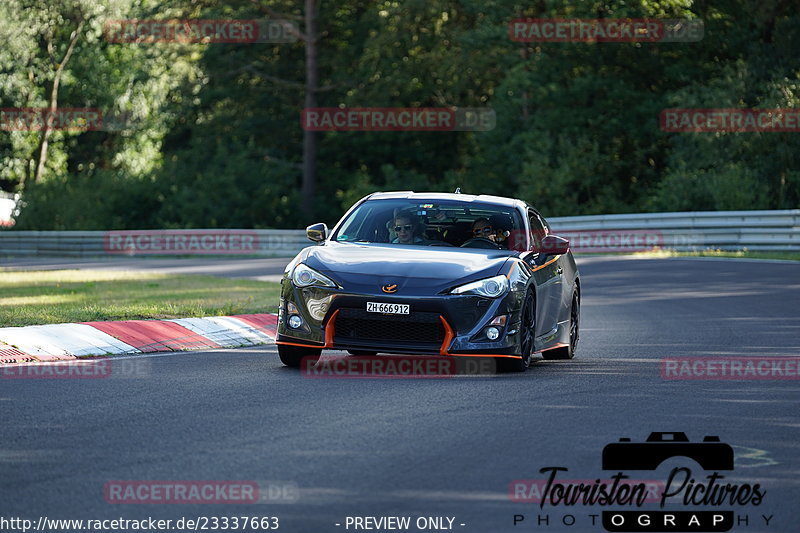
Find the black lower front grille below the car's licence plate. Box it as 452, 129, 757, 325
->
334, 308, 444, 346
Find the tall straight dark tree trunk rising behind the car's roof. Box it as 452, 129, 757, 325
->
302, 0, 319, 220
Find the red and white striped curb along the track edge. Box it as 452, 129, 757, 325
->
0, 313, 278, 365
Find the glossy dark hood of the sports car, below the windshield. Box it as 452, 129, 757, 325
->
303, 242, 517, 296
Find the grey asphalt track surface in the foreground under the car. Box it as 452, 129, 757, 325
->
0, 257, 800, 533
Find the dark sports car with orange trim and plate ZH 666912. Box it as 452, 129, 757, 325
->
277, 192, 581, 371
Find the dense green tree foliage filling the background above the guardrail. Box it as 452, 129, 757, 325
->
0, 0, 800, 229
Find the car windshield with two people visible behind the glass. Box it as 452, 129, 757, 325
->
332, 199, 526, 250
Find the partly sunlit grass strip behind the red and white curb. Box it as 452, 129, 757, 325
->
0, 270, 280, 327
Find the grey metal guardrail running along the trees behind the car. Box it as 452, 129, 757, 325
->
0, 209, 800, 257
